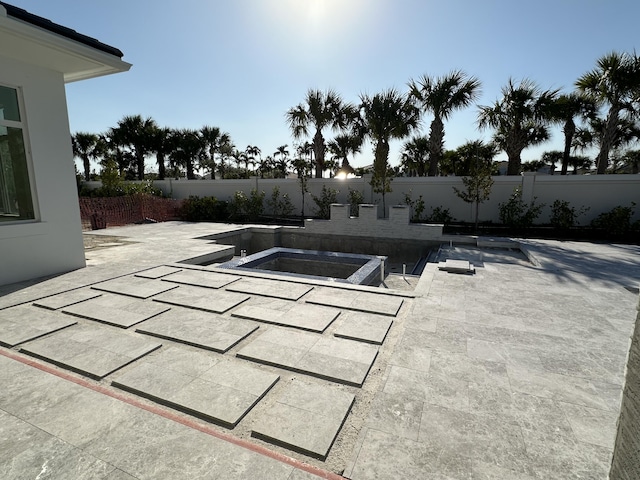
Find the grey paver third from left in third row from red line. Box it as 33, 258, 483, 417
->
231, 303, 340, 332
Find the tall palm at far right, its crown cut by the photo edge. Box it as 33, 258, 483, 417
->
576, 52, 640, 174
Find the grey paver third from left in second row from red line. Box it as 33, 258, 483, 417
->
136, 308, 258, 353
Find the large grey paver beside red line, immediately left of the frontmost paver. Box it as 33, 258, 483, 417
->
112, 348, 280, 428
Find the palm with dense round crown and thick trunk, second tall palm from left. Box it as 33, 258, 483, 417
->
360, 89, 420, 215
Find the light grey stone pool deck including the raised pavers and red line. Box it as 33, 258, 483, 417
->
0, 222, 640, 480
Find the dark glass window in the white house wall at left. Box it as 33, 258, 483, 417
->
0, 85, 35, 222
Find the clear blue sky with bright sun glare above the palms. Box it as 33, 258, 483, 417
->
9, 0, 640, 170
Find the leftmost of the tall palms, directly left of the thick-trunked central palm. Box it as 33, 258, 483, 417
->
286, 89, 356, 178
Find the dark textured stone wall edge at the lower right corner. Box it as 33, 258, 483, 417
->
609, 292, 640, 480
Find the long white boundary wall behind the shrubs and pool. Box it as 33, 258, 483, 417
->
89, 173, 640, 225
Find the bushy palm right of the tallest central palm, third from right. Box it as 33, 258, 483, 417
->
478, 79, 558, 175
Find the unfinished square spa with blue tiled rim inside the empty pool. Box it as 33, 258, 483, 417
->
217, 247, 387, 285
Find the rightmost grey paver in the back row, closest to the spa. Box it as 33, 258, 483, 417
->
304, 288, 403, 317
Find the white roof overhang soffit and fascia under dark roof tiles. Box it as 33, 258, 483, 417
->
0, 5, 131, 83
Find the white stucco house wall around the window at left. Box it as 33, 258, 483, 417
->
0, 55, 85, 285
